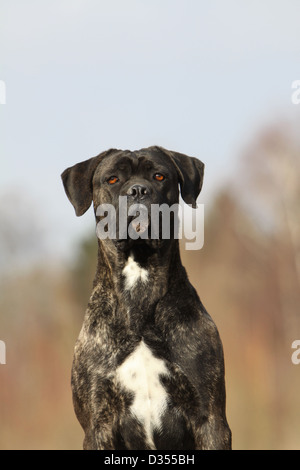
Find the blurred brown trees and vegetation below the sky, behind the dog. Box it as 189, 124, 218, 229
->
0, 119, 300, 449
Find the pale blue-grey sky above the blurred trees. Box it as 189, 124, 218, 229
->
0, 0, 300, 270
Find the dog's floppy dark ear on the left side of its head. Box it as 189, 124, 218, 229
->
61, 149, 116, 216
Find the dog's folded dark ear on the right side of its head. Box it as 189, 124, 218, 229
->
158, 147, 204, 208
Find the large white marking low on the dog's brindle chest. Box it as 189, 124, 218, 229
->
117, 341, 169, 449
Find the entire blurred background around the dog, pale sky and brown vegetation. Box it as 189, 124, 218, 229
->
0, 0, 300, 449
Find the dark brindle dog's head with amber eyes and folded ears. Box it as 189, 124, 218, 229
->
62, 147, 204, 250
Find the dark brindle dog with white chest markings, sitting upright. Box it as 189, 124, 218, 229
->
61, 146, 231, 450
